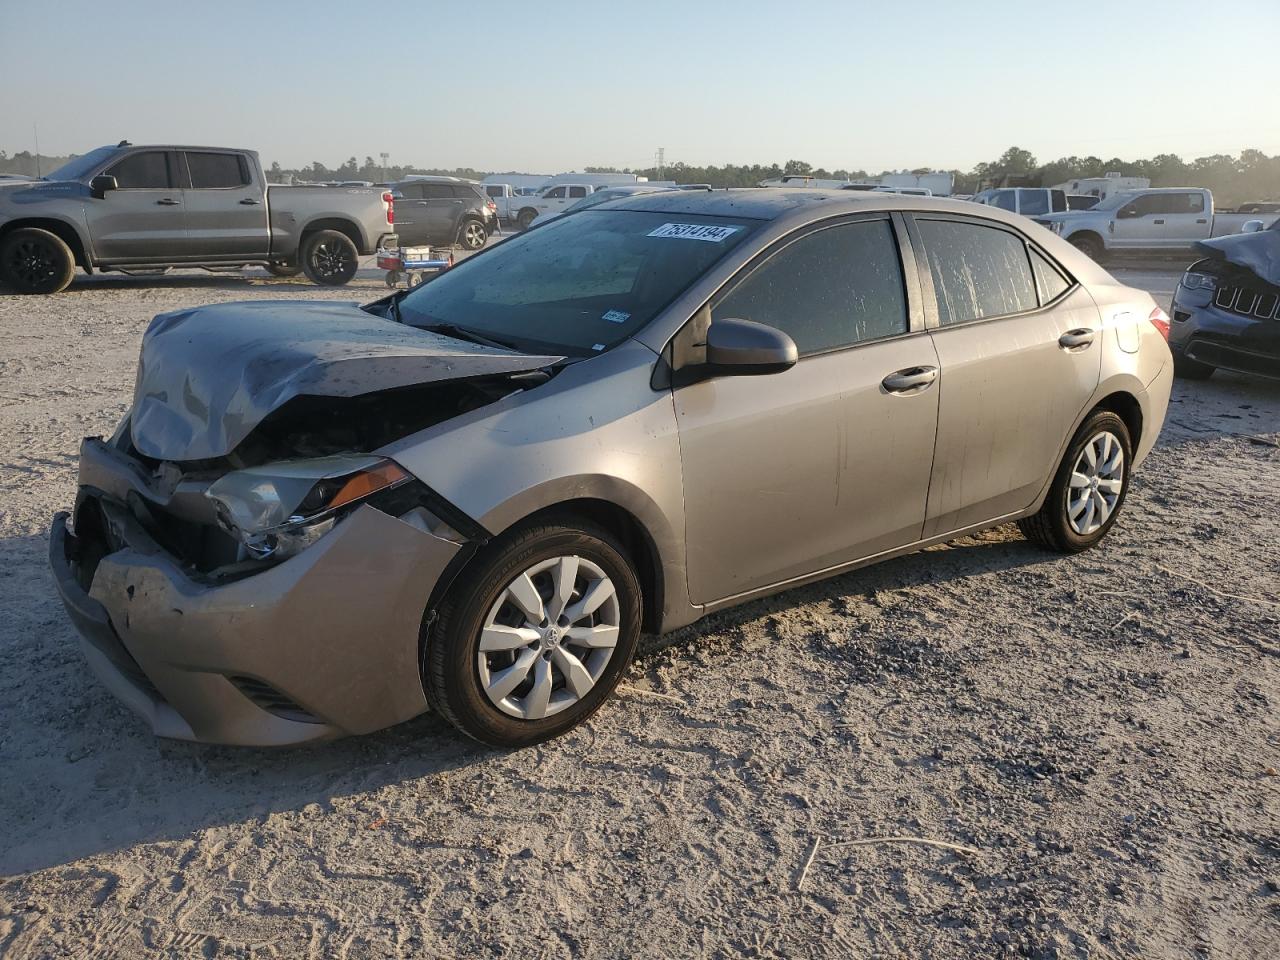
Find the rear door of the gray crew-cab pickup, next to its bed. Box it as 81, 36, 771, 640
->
178, 150, 271, 260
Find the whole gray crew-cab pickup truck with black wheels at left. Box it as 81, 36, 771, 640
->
0, 142, 394, 293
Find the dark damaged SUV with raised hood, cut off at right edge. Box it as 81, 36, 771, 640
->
1169, 220, 1280, 380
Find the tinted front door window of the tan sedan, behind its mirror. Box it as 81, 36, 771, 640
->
712, 220, 908, 356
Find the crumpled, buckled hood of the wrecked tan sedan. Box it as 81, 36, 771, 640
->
129, 301, 561, 461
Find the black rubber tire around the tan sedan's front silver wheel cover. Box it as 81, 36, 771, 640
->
424, 517, 640, 748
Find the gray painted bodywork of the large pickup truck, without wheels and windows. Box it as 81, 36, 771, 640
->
0, 145, 394, 268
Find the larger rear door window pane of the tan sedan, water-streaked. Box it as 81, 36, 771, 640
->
916, 220, 1039, 326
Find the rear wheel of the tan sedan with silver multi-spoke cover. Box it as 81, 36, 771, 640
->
1018, 410, 1133, 553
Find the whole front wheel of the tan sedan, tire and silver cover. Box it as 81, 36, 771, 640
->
424, 521, 640, 748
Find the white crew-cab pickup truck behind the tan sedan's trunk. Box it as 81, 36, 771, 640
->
1032, 187, 1276, 260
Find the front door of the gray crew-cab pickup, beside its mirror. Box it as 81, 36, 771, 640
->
88, 150, 187, 264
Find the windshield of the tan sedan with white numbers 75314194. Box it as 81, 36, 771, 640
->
399, 210, 760, 357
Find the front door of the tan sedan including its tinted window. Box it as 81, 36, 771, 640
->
675, 216, 937, 603
